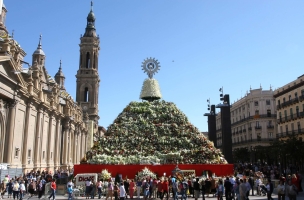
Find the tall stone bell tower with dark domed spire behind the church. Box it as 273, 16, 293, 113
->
76, 2, 100, 133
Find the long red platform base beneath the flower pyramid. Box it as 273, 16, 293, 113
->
74, 164, 233, 179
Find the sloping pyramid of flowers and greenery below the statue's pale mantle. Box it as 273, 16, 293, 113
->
86, 100, 227, 164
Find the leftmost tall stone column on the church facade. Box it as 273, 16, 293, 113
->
6, 100, 18, 164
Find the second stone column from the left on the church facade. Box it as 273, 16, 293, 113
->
22, 102, 31, 169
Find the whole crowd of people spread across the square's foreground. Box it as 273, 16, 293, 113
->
0, 164, 303, 200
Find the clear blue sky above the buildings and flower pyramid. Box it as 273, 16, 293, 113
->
4, 0, 304, 131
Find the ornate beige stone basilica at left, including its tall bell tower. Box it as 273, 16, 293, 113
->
0, 2, 105, 172
